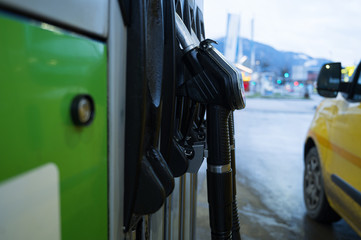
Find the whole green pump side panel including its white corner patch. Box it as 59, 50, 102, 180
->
0, 12, 108, 240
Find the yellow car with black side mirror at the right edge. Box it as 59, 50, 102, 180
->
303, 63, 361, 236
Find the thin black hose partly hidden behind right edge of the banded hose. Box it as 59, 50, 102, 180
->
228, 112, 241, 240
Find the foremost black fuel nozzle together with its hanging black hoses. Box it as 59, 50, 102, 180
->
176, 14, 245, 239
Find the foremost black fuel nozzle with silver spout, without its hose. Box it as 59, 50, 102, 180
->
176, 14, 245, 110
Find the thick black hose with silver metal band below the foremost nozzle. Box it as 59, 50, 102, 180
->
207, 105, 232, 240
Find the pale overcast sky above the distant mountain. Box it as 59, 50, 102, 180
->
204, 0, 361, 65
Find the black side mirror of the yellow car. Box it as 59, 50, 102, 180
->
317, 62, 341, 98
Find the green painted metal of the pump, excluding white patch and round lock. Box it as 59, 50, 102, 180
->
0, 12, 108, 240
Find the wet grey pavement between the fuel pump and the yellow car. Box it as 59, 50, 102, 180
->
197, 95, 361, 240
